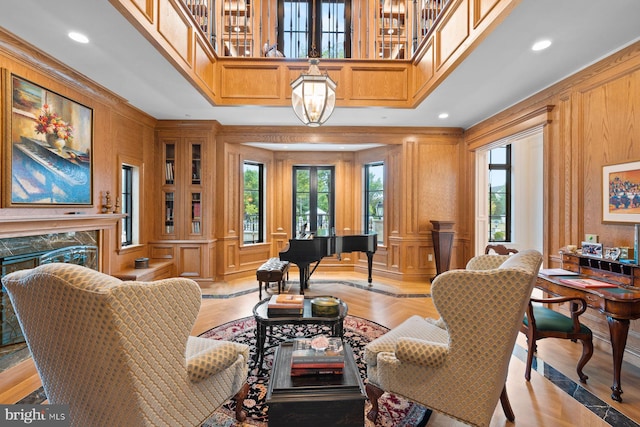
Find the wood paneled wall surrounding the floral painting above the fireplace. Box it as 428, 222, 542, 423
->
0, 29, 156, 272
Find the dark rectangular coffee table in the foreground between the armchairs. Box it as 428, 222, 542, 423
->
267, 341, 367, 427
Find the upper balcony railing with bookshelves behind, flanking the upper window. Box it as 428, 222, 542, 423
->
183, 0, 451, 60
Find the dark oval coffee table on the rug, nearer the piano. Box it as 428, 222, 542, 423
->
253, 296, 349, 369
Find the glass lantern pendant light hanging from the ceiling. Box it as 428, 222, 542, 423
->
291, 0, 336, 127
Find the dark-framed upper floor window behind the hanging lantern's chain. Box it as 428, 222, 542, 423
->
278, 0, 351, 58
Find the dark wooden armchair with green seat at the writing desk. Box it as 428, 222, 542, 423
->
520, 297, 593, 383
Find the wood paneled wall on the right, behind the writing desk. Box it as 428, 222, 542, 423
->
464, 43, 640, 358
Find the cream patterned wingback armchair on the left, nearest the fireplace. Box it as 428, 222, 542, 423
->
2, 263, 249, 427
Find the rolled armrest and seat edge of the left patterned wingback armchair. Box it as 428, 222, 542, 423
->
187, 337, 249, 382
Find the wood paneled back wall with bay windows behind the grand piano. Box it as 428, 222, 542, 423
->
217, 126, 470, 279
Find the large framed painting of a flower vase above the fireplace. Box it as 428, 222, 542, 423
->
3, 70, 93, 207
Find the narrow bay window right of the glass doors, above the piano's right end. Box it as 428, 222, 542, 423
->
364, 162, 384, 245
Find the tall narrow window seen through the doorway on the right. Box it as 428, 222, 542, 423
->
489, 145, 511, 242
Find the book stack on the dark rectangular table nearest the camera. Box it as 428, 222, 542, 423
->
291, 335, 344, 377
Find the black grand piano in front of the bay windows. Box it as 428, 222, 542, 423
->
280, 232, 378, 295
